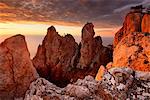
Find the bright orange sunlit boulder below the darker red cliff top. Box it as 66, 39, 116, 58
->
113, 32, 150, 71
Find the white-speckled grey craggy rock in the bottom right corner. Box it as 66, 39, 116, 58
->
101, 67, 150, 100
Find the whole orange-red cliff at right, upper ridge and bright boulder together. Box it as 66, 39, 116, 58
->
113, 6, 150, 71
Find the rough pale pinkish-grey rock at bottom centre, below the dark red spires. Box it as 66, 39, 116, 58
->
24, 76, 112, 100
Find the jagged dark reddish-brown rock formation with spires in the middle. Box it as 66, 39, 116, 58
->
33, 23, 112, 87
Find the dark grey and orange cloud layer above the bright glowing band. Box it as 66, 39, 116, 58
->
0, 0, 150, 27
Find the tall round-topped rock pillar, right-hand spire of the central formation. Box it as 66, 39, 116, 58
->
78, 23, 102, 68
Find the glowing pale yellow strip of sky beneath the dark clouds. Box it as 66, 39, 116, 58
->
0, 21, 120, 37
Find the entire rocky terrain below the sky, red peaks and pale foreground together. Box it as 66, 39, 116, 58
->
0, 6, 150, 100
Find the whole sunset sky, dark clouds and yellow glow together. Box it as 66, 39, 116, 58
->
0, 0, 150, 37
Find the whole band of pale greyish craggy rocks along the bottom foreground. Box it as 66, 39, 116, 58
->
25, 67, 150, 100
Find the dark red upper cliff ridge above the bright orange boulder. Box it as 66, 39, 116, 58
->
113, 9, 150, 47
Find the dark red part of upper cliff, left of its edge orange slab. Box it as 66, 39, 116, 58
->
113, 12, 143, 47
